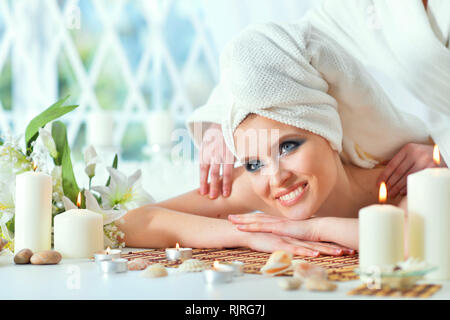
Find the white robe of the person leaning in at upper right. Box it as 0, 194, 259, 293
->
305, 0, 450, 164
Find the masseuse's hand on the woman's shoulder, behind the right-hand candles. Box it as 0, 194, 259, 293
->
377, 143, 446, 198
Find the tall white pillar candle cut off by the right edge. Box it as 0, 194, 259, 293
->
407, 168, 450, 280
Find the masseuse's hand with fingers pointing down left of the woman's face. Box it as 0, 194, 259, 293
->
200, 123, 234, 199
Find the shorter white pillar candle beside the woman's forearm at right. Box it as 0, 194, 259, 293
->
358, 204, 405, 269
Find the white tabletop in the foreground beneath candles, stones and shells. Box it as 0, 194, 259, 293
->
0, 249, 450, 300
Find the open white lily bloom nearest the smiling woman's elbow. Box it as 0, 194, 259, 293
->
92, 167, 154, 211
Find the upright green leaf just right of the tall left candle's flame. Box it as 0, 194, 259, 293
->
52, 121, 80, 203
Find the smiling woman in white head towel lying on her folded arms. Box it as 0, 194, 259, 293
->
118, 23, 428, 256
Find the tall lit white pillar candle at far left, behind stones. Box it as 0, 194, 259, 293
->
14, 171, 52, 253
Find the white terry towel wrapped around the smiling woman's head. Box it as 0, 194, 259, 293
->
188, 22, 428, 168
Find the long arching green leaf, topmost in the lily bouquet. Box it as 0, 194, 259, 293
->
25, 96, 78, 155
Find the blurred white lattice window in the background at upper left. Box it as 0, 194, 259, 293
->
0, 0, 218, 161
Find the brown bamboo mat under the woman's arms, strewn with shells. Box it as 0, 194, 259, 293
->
122, 248, 359, 281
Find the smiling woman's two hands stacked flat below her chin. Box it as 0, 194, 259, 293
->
232, 213, 355, 256
